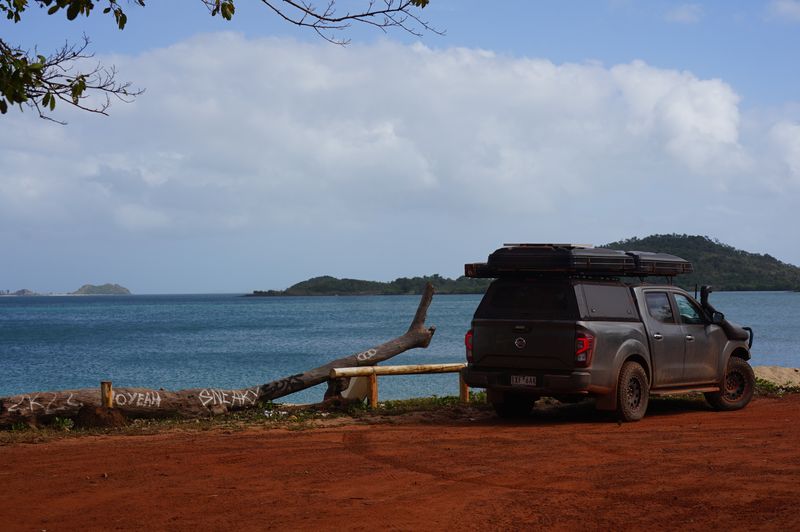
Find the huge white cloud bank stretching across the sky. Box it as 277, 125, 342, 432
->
0, 33, 772, 227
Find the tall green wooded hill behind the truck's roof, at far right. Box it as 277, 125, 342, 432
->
601, 234, 800, 290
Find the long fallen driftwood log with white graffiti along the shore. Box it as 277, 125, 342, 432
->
0, 284, 436, 426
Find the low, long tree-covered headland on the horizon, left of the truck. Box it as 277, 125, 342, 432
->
248, 274, 491, 296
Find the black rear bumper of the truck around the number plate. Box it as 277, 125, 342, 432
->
462, 366, 594, 395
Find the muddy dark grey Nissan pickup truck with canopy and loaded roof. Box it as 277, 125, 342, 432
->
463, 244, 755, 421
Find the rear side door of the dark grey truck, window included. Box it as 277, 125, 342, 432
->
642, 290, 685, 387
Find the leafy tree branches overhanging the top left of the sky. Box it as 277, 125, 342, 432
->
0, 0, 444, 124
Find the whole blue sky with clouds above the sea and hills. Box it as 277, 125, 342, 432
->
0, 0, 800, 294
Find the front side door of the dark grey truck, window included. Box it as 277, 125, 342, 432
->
672, 293, 720, 384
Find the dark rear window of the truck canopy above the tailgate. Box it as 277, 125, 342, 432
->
475, 279, 578, 320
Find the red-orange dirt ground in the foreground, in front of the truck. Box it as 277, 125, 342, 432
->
0, 395, 800, 530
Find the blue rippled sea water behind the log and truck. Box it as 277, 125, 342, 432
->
0, 292, 800, 402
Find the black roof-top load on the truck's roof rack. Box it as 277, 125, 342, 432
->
464, 244, 692, 277
